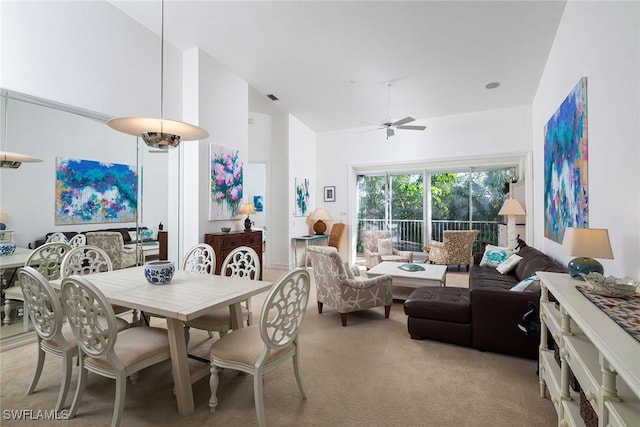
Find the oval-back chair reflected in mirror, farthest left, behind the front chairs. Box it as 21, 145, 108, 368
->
4, 242, 71, 331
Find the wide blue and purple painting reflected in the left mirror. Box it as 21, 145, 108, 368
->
56, 157, 138, 225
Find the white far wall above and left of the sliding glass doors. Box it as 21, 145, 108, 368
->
315, 106, 532, 260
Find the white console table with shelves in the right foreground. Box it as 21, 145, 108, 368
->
537, 272, 640, 426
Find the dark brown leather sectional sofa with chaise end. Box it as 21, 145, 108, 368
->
404, 241, 566, 359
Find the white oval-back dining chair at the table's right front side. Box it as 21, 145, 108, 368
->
209, 268, 311, 426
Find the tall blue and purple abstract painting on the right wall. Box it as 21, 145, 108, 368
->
544, 77, 589, 243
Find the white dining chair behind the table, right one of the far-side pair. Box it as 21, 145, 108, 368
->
185, 246, 260, 336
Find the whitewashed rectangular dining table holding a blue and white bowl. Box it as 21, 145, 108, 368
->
51, 266, 272, 416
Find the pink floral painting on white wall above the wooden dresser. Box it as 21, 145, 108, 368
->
209, 145, 243, 220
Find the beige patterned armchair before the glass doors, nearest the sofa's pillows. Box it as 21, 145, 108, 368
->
429, 230, 479, 271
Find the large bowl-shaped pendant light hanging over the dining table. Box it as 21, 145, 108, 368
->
107, 0, 209, 149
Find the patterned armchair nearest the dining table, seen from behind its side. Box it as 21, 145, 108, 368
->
307, 246, 393, 326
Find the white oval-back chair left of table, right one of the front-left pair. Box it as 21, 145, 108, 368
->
62, 275, 171, 426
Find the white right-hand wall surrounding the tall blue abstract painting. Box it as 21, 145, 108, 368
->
533, 1, 640, 279
